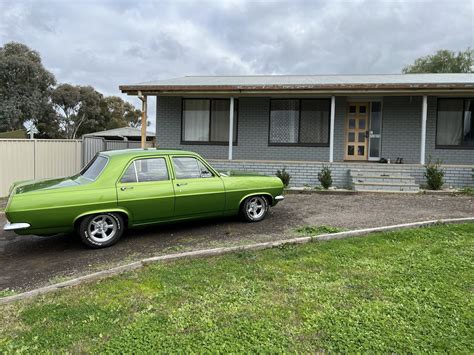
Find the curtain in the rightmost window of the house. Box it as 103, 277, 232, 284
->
436, 99, 463, 145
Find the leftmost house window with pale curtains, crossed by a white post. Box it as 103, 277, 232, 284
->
181, 99, 238, 144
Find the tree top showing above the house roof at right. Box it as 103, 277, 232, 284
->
402, 48, 474, 74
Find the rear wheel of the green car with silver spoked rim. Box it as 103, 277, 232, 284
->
77, 213, 125, 249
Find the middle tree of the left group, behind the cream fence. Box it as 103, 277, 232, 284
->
51, 84, 103, 139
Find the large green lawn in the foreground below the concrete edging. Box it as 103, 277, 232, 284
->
0, 224, 474, 353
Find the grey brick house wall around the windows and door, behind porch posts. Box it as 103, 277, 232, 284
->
156, 96, 474, 164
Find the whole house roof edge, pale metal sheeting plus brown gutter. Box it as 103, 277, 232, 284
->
120, 74, 474, 95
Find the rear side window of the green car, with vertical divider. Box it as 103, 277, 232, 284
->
120, 158, 169, 183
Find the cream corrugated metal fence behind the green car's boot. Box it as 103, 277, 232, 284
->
0, 137, 152, 197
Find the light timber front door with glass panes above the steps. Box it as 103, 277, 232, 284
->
344, 102, 370, 160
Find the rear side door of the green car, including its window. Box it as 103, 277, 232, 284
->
116, 157, 174, 224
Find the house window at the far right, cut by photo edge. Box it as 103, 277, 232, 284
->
436, 99, 474, 149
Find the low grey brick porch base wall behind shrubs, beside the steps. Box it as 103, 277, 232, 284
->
209, 160, 474, 188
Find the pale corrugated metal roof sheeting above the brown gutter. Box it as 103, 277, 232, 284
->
136, 74, 474, 86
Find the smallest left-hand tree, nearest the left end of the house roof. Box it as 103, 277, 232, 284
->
102, 96, 141, 129
